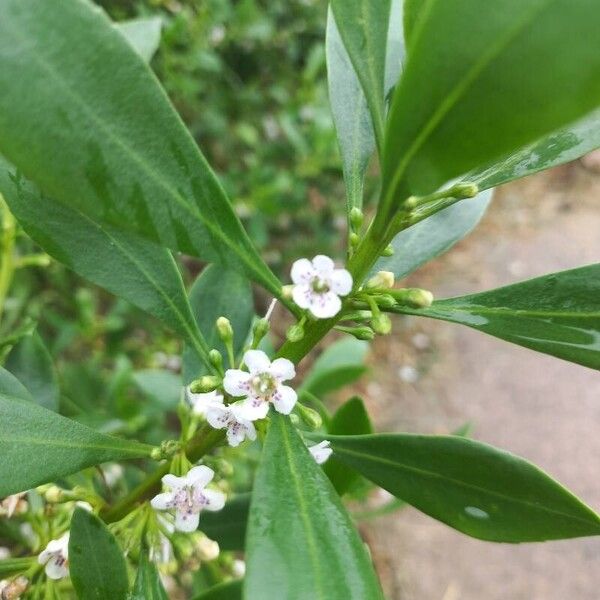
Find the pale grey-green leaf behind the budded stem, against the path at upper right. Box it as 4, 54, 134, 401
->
372, 190, 492, 279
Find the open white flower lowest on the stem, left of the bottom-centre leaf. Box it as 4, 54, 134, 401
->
150, 465, 225, 532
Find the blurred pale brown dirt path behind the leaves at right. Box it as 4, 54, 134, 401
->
361, 164, 600, 600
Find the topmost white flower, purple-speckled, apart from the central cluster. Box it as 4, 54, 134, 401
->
291, 254, 352, 319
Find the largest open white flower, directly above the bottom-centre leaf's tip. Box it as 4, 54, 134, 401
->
223, 350, 298, 421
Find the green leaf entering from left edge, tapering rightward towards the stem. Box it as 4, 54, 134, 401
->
0, 394, 152, 497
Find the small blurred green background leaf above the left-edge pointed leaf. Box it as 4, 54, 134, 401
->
5, 332, 60, 411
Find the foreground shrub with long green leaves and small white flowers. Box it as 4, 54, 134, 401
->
0, 0, 600, 600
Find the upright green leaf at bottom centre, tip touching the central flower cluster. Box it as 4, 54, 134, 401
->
244, 413, 382, 600
